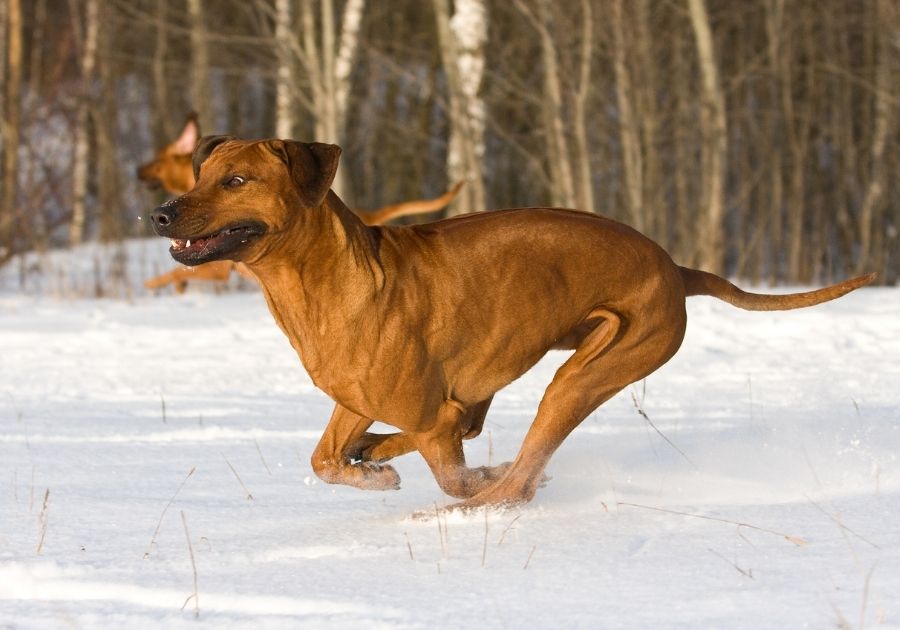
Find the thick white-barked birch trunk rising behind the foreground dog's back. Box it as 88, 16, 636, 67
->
433, 0, 488, 215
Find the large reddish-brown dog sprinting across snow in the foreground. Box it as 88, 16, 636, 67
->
151, 136, 874, 508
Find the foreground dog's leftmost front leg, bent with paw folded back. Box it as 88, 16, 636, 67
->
311, 405, 400, 490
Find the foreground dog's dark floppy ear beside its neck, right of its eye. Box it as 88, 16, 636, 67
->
269, 140, 341, 208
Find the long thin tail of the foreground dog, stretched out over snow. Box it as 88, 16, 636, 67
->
678, 267, 877, 311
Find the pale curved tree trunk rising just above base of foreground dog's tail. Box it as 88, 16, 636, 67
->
687, 0, 728, 274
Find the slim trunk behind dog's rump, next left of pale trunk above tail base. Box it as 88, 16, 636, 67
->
610, 0, 646, 232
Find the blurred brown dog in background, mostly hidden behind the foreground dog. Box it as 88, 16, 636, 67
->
137, 112, 463, 294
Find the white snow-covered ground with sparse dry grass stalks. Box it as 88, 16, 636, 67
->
0, 239, 900, 629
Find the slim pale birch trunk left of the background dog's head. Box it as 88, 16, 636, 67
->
69, 0, 99, 245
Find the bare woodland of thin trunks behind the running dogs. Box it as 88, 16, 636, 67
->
0, 0, 900, 284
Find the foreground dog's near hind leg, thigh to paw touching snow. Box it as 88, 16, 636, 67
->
451, 305, 685, 509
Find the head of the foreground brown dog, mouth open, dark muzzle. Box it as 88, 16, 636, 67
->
150, 136, 341, 265
